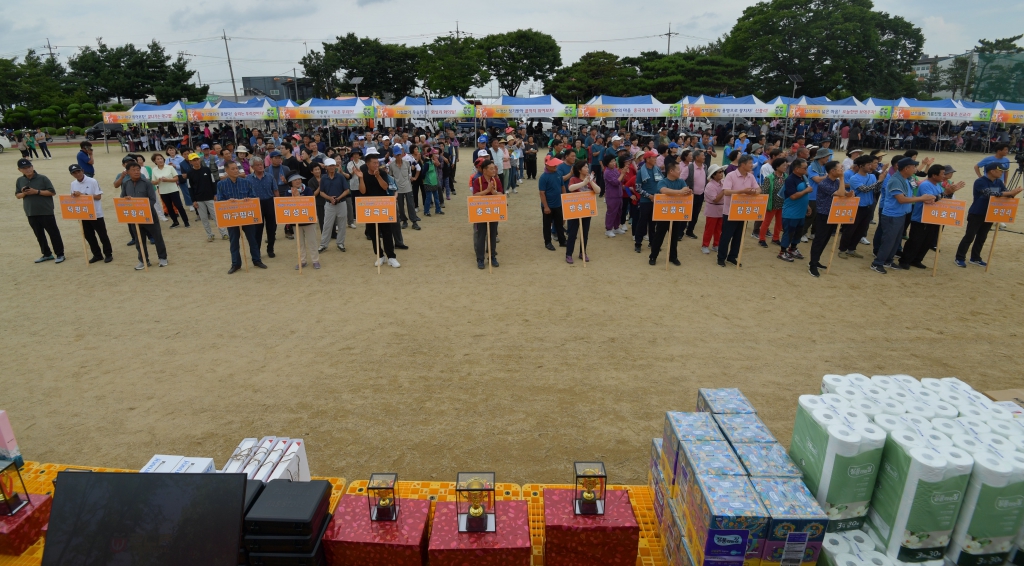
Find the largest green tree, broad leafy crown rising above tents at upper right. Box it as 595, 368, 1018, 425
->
722, 0, 925, 97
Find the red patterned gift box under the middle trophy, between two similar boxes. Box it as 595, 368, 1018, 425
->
427, 502, 534, 566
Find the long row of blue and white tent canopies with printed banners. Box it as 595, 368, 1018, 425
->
103, 95, 1024, 124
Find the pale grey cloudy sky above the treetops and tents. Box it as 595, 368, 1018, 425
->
0, 0, 1024, 96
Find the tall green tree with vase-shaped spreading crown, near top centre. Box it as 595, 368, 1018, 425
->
480, 30, 562, 96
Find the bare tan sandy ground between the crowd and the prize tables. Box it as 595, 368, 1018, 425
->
0, 146, 1024, 483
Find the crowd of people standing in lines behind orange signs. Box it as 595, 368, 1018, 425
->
16, 118, 1020, 276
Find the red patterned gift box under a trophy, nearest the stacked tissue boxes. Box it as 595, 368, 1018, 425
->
544, 489, 640, 566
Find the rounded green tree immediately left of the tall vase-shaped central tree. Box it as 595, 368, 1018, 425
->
420, 36, 490, 96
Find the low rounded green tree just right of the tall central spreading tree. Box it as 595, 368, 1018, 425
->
544, 51, 637, 102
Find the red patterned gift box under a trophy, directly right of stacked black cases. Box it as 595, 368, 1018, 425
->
323, 494, 430, 566
